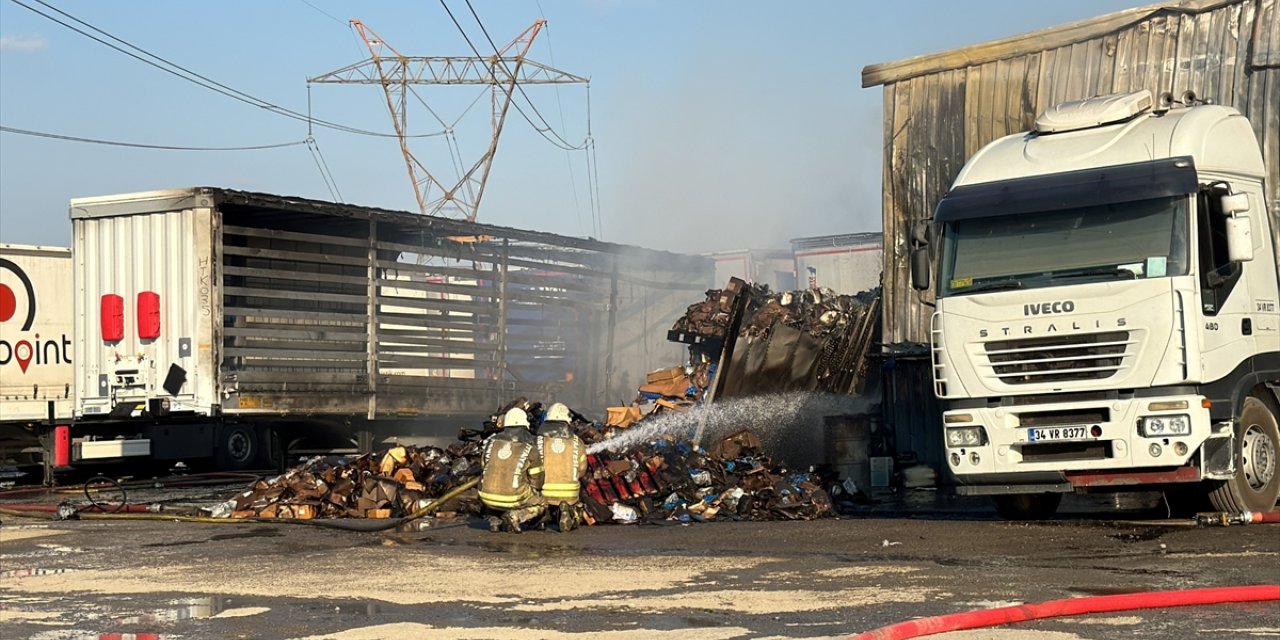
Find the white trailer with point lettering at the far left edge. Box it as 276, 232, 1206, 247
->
0, 244, 74, 463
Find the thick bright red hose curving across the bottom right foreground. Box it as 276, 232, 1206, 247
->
851, 585, 1280, 640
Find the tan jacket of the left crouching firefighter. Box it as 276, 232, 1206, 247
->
480, 428, 543, 509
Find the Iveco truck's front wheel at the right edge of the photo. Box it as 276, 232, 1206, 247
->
1208, 389, 1280, 513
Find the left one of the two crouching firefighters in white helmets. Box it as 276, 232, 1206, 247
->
480, 408, 547, 534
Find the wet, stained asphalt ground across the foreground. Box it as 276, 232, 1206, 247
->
0, 488, 1280, 640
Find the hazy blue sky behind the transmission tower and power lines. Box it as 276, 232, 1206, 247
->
0, 0, 1147, 252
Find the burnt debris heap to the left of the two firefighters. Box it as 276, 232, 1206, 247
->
211, 442, 480, 520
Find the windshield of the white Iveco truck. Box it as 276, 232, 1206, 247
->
938, 196, 1190, 297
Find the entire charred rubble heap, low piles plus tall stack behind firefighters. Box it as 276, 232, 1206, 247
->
212, 279, 878, 524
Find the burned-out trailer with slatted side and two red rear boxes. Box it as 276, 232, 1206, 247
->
72, 187, 710, 467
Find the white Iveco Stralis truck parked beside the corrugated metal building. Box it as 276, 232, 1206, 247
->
911, 91, 1280, 518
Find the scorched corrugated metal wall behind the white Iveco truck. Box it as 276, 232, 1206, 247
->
863, 0, 1280, 343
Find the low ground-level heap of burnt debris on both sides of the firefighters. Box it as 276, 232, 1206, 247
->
210, 401, 835, 525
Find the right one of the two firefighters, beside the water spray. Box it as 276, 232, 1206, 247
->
538, 402, 586, 532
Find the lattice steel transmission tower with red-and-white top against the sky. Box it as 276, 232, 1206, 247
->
307, 19, 590, 221
